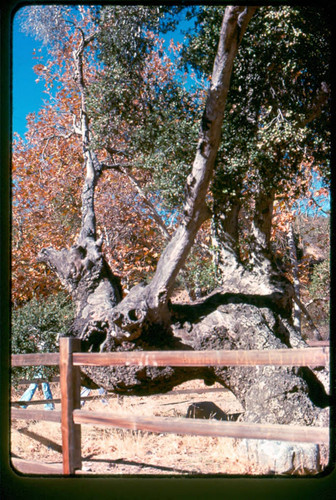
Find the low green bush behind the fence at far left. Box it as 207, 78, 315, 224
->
11, 292, 74, 382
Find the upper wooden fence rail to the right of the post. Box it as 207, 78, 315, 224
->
73, 347, 329, 367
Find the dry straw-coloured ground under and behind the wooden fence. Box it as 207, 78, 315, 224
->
11, 381, 328, 476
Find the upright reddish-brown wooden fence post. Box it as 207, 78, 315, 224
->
59, 337, 82, 474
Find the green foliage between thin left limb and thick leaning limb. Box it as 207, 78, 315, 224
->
88, 7, 201, 210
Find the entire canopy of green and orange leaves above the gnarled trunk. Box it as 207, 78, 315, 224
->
13, 2, 330, 316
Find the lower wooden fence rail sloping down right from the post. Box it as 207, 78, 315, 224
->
73, 410, 329, 443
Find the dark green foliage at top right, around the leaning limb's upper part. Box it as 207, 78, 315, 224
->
182, 6, 331, 200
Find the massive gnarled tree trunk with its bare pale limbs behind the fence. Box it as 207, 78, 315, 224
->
39, 6, 328, 472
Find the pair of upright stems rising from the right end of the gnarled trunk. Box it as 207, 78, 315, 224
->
212, 186, 294, 315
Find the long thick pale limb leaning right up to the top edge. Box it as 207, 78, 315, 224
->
115, 6, 256, 328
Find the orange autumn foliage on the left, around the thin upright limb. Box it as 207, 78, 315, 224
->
12, 25, 176, 305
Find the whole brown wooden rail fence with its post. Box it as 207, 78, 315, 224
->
11, 337, 329, 475
